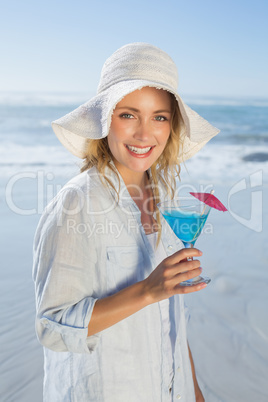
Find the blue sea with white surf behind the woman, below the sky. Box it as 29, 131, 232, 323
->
0, 92, 268, 184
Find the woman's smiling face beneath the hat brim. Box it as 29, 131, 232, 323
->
108, 87, 171, 181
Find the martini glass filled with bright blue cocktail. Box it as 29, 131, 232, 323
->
157, 198, 211, 286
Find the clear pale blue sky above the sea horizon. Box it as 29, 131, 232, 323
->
0, 0, 268, 98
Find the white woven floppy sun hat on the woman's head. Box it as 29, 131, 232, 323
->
52, 42, 219, 162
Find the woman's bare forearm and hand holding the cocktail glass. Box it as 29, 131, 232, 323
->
88, 248, 206, 336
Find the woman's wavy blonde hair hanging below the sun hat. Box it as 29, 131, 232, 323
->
81, 94, 184, 245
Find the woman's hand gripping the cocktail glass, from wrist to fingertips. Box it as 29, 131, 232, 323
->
144, 248, 206, 303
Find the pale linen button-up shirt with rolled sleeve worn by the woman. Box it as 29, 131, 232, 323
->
33, 168, 195, 402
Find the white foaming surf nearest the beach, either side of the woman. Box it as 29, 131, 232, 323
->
0, 143, 268, 184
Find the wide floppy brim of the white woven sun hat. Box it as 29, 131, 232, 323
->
52, 80, 220, 162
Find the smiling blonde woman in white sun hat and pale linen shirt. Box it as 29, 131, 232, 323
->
34, 43, 218, 402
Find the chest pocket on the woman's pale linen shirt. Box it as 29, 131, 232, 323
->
106, 246, 144, 293
